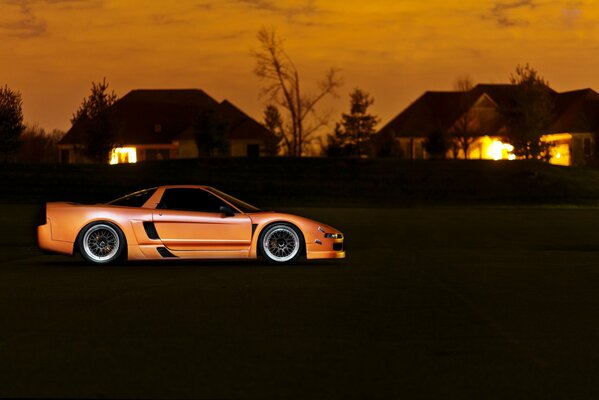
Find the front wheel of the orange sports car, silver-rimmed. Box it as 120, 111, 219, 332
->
258, 223, 304, 264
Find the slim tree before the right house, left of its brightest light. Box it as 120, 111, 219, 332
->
450, 76, 477, 159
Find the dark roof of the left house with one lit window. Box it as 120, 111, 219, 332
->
60, 89, 268, 145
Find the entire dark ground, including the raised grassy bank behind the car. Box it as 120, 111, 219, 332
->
0, 159, 599, 399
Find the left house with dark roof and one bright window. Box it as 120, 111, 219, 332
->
58, 89, 272, 164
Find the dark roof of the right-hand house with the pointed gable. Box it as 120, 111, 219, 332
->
377, 84, 599, 140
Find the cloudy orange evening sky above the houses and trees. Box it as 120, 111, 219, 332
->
0, 0, 599, 134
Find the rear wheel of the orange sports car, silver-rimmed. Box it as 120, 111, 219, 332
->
77, 222, 127, 265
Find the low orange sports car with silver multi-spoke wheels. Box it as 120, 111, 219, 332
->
37, 185, 345, 264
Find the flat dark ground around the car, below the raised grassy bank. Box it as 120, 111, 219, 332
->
0, 206, 599, 399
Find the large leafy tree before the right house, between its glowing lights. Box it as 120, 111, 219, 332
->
503, 64, 554, 160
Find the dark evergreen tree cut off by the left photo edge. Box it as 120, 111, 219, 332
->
0, 85, 25, 162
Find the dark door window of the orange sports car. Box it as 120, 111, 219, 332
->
158, 188, 232, 213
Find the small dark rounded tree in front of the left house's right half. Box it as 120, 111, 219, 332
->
193, 110, 230, 157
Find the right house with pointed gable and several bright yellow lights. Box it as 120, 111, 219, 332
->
373, 84, 599, 165
